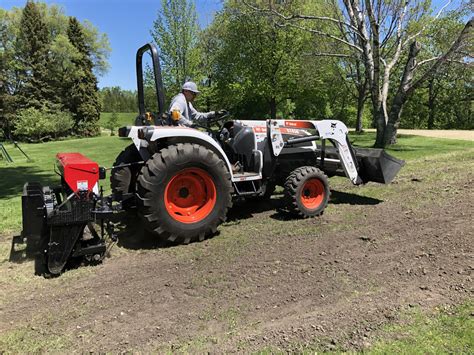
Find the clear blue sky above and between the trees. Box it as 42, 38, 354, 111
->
0, 0, 222, 90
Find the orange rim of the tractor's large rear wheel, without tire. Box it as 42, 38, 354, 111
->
164, 168, 216, 223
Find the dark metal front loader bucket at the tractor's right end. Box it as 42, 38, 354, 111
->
354, 148, 405, 184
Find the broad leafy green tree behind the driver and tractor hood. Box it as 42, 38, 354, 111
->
207, 1, 322, 118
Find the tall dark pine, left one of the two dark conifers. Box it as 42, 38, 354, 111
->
16, 0, 54, 109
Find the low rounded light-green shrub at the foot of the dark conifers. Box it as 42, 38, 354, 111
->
13, 107, 74, 142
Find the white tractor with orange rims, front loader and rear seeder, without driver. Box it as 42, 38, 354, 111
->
22, 44, 404, 275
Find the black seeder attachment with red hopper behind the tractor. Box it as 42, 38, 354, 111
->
22, 153, 121, 275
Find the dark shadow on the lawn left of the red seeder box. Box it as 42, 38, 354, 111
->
0, 166, 58, 198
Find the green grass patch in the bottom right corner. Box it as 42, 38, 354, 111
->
368, 301, 474, 354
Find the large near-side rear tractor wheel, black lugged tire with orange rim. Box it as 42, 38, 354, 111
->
137, 143, 232, 244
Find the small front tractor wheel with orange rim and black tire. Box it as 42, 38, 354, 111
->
285, 166, 331, 218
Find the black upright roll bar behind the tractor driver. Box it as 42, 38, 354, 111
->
136, 43, 165, 117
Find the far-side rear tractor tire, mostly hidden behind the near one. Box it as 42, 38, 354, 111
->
110, 144, 142, 193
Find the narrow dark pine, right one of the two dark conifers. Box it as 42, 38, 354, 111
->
67, 17, 100, 136
